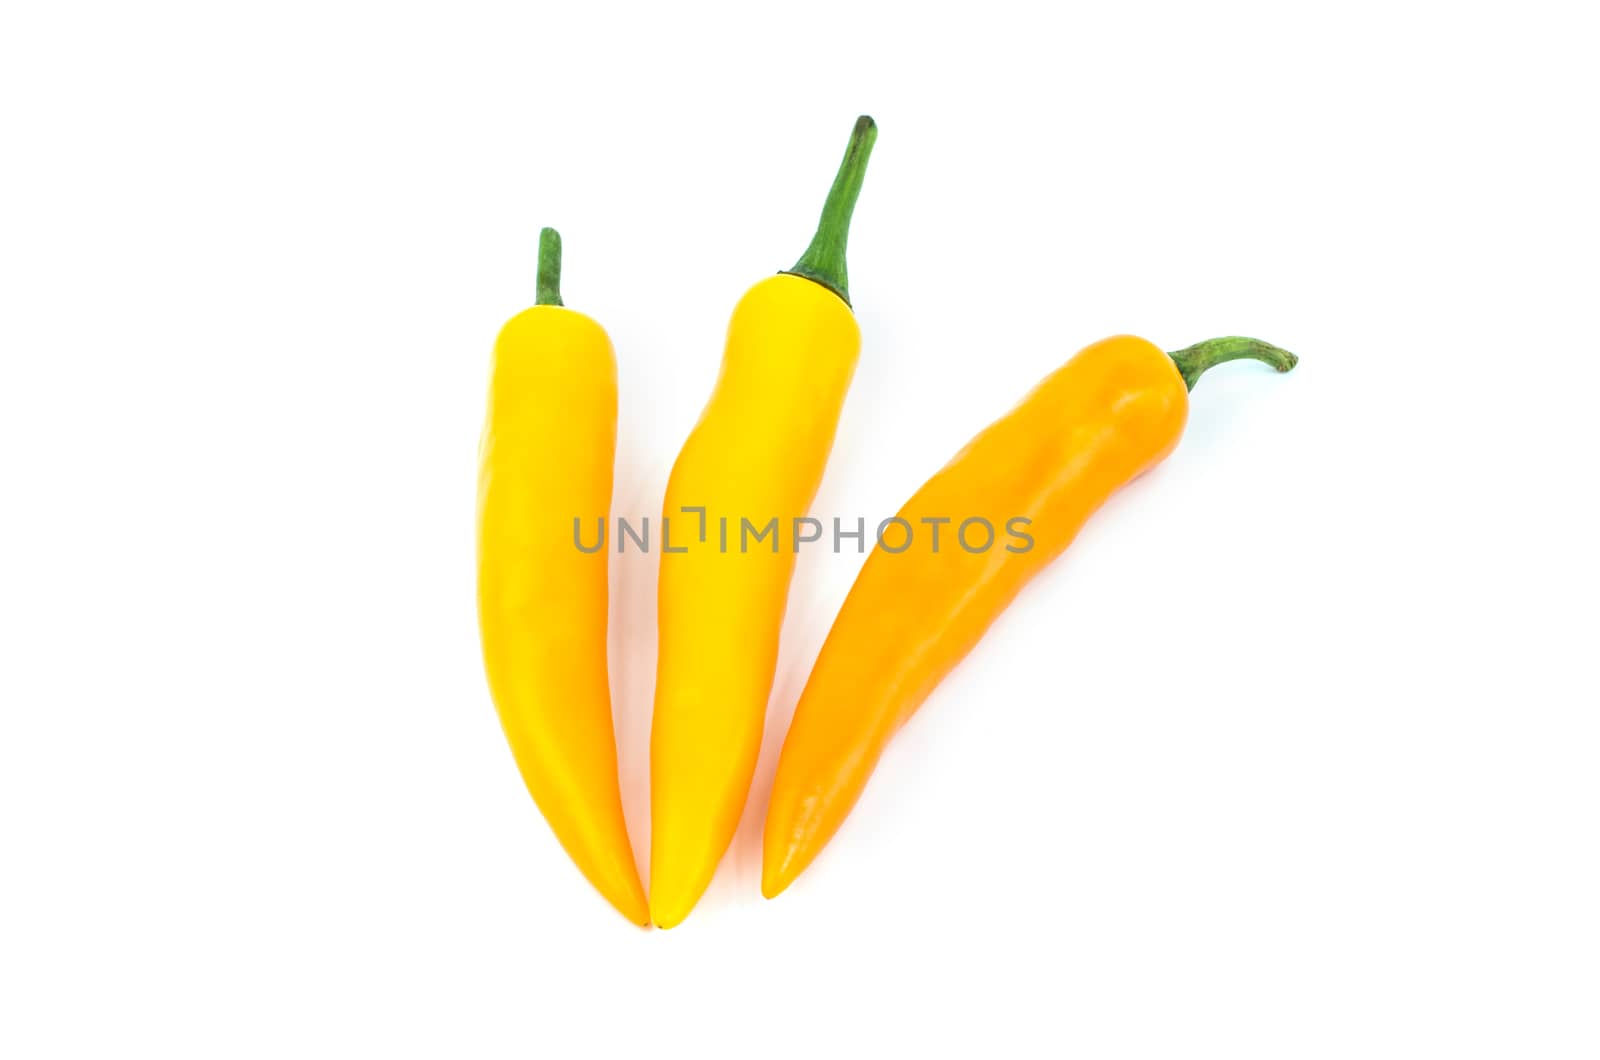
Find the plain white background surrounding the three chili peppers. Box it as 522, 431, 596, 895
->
0, 0, 1600, 1058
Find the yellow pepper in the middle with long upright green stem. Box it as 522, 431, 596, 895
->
650, 117, 877, 927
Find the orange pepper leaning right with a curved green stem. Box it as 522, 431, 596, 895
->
762, 336, 1294, 898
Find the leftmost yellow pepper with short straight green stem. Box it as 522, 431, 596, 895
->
478, 229, 650, 925
